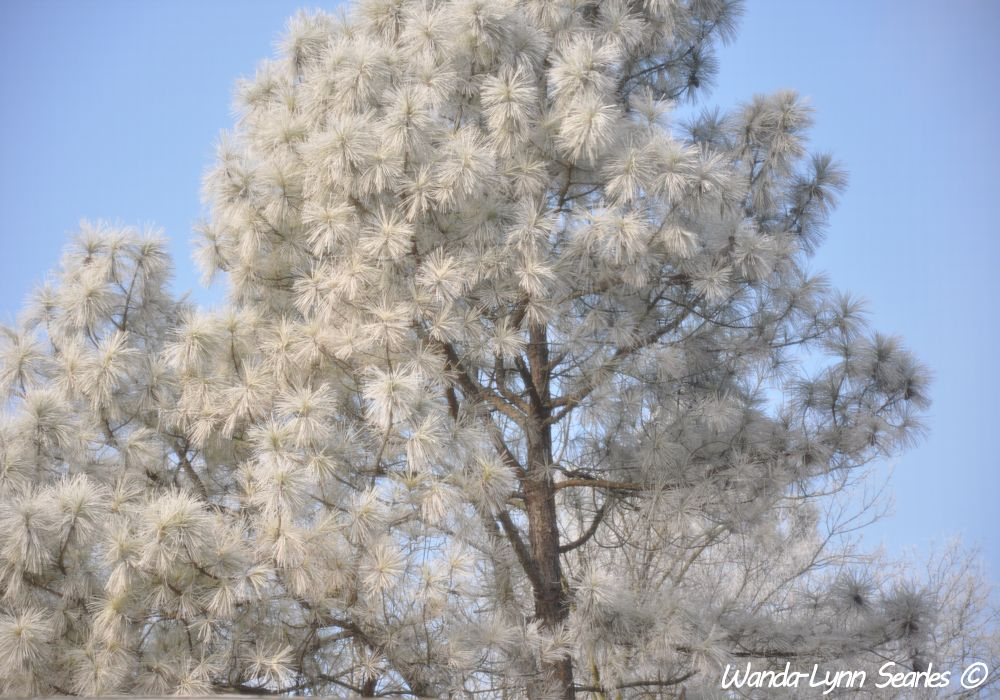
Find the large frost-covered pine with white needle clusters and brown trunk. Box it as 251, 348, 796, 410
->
0, 0, 996, 700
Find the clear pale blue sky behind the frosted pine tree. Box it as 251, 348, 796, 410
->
0, 0, 1000, 580
